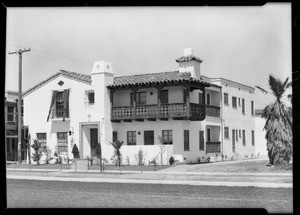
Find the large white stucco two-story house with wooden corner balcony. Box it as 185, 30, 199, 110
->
24, 49, 255, 164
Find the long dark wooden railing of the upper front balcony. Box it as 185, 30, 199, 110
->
112, 103, 205, 120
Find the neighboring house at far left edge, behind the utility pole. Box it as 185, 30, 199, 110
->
4, 91, 27, 161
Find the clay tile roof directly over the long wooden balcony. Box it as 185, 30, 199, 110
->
107, 71, 211, 89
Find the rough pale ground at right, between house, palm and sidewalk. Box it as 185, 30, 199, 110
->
189, 160, 293, 173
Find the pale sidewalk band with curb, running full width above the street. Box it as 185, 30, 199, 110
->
6, 168, 293, 188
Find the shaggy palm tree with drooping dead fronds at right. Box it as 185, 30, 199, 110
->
256, 75, 293, 166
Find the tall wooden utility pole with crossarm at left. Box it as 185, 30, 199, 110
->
8, 48, 30, 163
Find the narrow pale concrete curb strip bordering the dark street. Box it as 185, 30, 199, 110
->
7, 175, 293, 188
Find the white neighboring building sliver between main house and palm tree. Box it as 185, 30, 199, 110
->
255, 109, 268, 157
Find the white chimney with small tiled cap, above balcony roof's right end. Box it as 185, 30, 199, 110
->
176, 48, 202, 79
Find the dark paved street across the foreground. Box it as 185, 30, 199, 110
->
7, 179, 293, 213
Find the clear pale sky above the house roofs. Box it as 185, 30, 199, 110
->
5, 3, 292, 108
